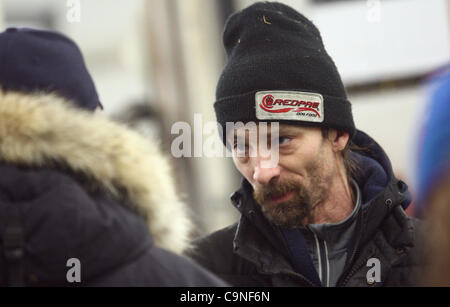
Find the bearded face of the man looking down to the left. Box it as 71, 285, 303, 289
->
229, 124, 336, 228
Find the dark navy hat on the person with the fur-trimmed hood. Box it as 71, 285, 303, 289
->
0, 28, 101, 110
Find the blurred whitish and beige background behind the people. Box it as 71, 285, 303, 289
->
0, 0, 450, 235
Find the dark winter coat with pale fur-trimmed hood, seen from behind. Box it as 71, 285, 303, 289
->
0, 91, 224, 286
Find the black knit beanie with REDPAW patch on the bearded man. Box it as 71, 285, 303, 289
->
214, 2, 355, 143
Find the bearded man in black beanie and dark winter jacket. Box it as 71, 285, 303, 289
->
187, 2, 419, 287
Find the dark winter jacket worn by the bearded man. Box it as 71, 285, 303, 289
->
187, 131, 422, 286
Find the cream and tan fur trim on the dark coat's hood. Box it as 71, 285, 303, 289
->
0, 90, 191, 253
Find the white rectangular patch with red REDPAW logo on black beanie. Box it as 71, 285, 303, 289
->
255, 91, 324, 123
